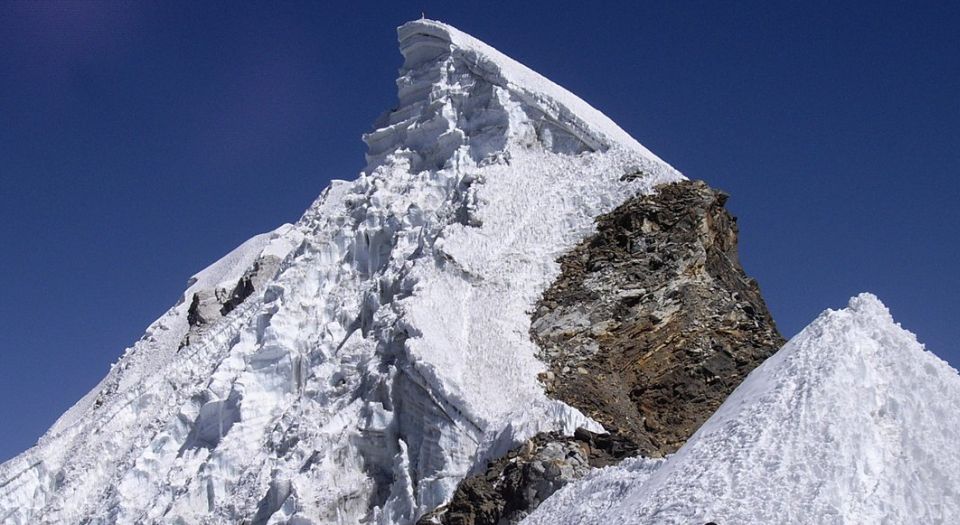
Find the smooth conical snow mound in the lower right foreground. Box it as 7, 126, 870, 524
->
523, 294, 960, 525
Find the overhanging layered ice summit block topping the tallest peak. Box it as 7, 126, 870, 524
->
364, 20, 675, 175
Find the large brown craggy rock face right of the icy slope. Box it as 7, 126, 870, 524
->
531, 181, 784, 456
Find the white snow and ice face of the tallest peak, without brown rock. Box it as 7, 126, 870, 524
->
0, 20, 682, 524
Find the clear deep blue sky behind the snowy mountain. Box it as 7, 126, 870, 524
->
0, 0, 960, 459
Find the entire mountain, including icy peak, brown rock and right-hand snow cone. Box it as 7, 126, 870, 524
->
0, 20, 960, 525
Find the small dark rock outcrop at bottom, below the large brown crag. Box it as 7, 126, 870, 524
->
419, 429, 636, 525
